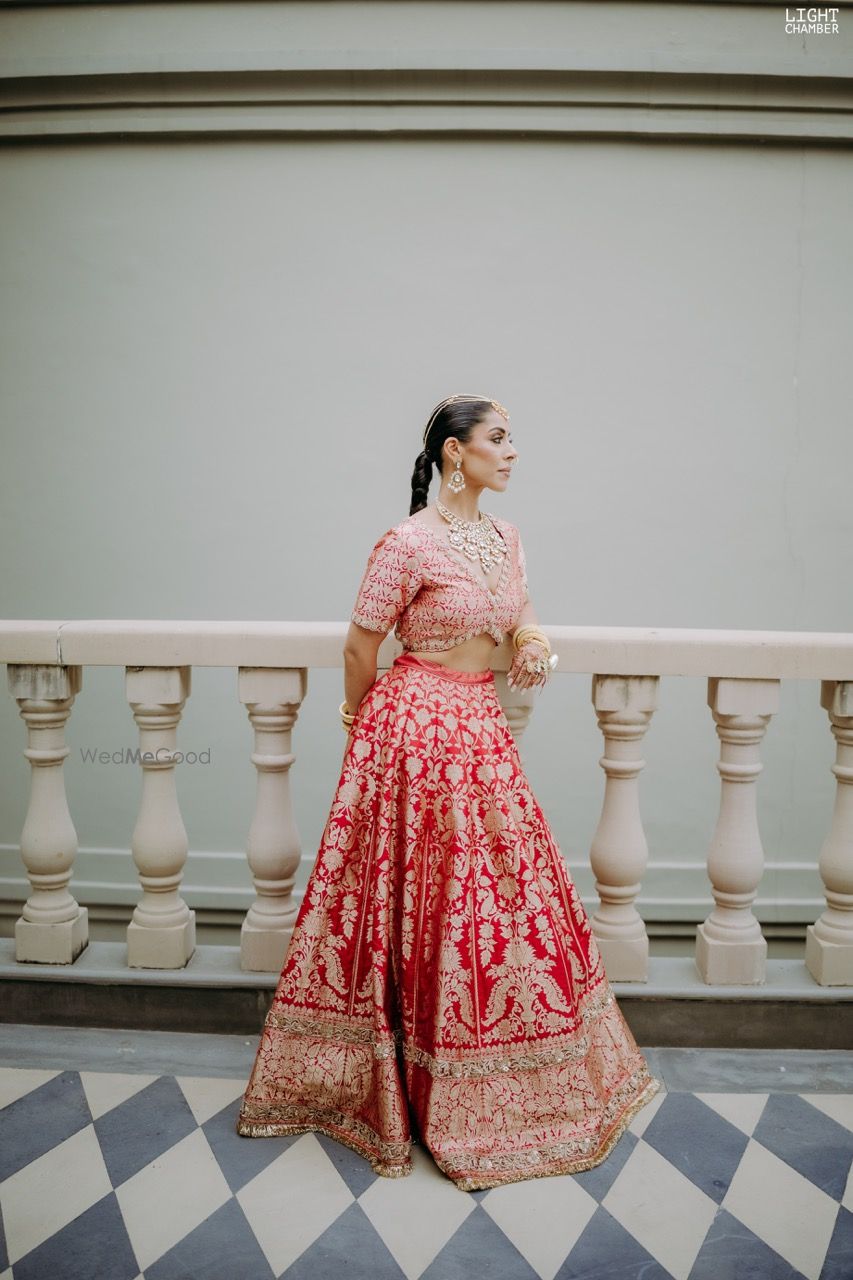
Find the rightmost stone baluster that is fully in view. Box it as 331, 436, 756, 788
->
695, 676, 780, 984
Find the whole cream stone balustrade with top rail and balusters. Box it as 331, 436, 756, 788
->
0, 621, 853, 986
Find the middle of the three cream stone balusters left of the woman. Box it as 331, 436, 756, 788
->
126, 667, 196, 969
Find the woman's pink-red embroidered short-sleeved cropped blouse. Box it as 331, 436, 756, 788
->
351, 516, 528, 652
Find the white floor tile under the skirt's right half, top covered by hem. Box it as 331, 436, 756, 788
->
480, 1174, 598, 1280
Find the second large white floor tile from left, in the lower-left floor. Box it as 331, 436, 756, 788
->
115, 1129, 231, 1271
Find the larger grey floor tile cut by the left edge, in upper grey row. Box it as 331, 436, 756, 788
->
0, 1071, 92, 1181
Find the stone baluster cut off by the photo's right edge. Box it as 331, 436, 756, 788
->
806, 680, 853, 987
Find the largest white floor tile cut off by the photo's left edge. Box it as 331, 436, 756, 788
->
0, 1125, 111, 1266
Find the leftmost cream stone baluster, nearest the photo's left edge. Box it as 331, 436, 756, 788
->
8, 663, 88, 964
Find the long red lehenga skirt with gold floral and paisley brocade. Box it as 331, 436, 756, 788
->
237, 654, 660, 1190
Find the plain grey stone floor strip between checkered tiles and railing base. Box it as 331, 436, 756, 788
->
0, 1023, 853, 1093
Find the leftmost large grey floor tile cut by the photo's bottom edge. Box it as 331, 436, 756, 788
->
14, 1192, 140, 1280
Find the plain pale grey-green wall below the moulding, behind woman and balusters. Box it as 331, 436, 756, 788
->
0, 6, 853, 942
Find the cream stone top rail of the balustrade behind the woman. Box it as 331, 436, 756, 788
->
0, 618, 853, 680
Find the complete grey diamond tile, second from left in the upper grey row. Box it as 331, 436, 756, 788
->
95, 1075, 199, 1187
